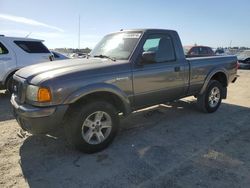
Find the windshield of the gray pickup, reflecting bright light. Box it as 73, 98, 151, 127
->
90, 32, 141, 60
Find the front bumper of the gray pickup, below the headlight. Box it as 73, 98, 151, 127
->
11, 95, 68, 134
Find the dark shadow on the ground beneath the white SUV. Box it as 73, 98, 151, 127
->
0, 91, 14, 122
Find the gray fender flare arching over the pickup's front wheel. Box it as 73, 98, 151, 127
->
63, 83, 132, 115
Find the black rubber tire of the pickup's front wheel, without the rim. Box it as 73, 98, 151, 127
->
64, 101, 119, 153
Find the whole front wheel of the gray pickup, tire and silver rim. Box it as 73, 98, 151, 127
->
65, 101, 119, 153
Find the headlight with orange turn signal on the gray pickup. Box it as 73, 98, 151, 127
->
26, 85, 52, 102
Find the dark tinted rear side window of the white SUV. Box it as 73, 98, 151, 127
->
14, 41, 50, 53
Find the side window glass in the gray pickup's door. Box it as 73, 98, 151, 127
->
143, 35, 175, 63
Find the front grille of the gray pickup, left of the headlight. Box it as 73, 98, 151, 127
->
13, 76, 25, 103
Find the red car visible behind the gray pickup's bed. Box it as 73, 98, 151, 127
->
184, 46, 215, 57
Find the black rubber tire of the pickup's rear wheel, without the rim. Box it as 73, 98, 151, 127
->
197, 80, 223, 113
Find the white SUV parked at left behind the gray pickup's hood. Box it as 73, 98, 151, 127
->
0, 35, 52, 90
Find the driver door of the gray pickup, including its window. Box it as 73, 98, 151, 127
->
133, 34, 185, 107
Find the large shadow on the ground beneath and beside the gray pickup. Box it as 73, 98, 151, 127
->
20, 101, 250, 187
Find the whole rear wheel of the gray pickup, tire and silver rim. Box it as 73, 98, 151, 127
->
197, 80, 222, 113
